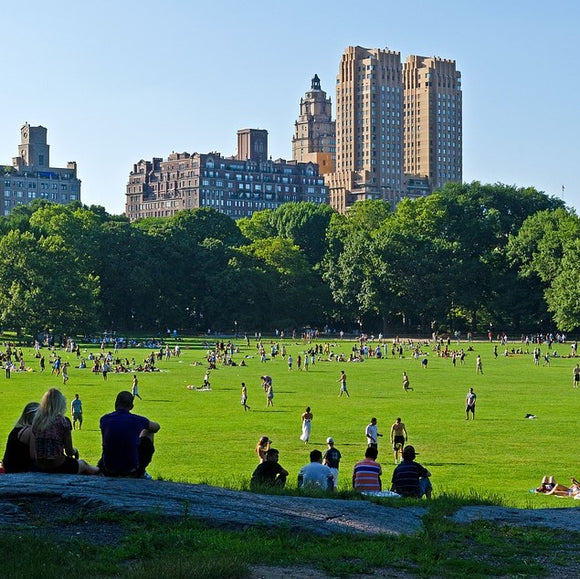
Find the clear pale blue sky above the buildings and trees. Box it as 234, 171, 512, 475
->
0, 0, 580, 214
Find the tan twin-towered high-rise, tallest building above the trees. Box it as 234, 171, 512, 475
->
325, 46, 462, 211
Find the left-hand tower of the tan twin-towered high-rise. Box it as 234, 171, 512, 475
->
328, 46, 403, 211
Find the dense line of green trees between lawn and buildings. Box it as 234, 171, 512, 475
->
0, 182, 580, 334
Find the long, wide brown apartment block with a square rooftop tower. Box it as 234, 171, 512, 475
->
125, 129, 328, 221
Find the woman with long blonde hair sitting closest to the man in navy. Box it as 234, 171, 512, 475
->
30, 388, 99, 474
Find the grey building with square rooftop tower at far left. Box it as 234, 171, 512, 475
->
0, 123, 81, 215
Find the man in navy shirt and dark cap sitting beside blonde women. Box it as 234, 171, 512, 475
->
98, 391, 161, 478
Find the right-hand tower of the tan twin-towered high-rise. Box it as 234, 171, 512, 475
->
403, 56, 463, 191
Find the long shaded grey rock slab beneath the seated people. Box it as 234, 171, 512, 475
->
0, 473, 427, 535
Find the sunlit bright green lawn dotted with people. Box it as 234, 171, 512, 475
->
0, 339, 580, 507
